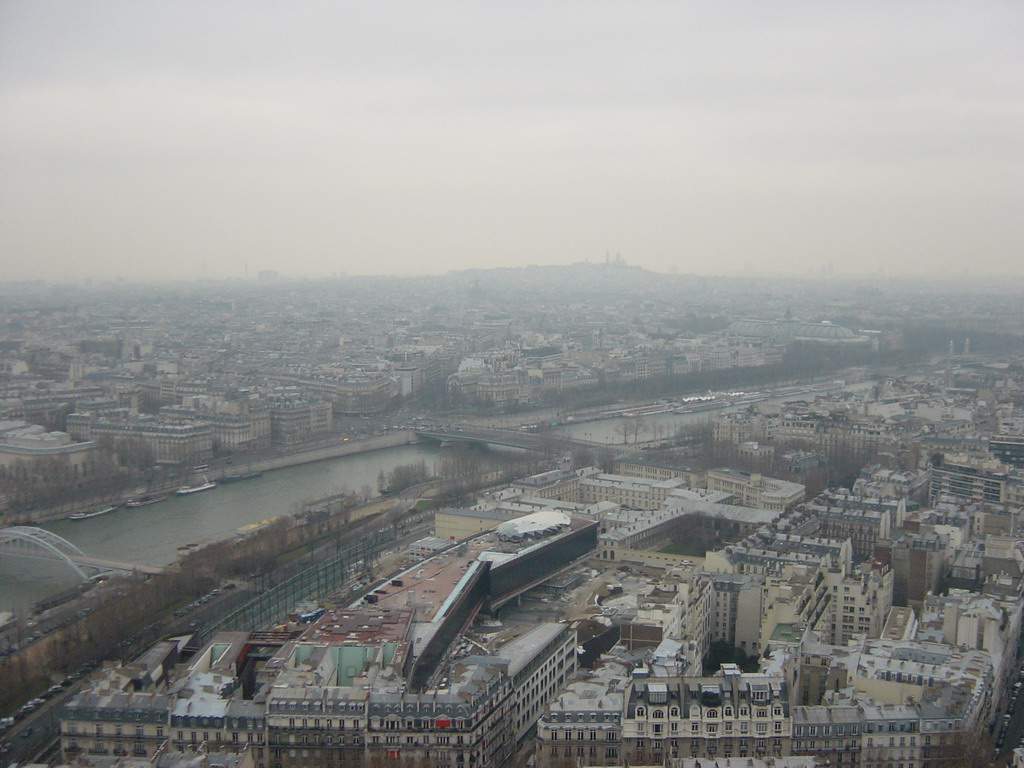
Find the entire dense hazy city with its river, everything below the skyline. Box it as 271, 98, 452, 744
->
0, 266, 1024, 768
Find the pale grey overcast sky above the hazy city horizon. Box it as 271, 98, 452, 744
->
0, 0, 1024, 281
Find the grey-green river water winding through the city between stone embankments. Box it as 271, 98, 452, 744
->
0, 382, 870, 613
